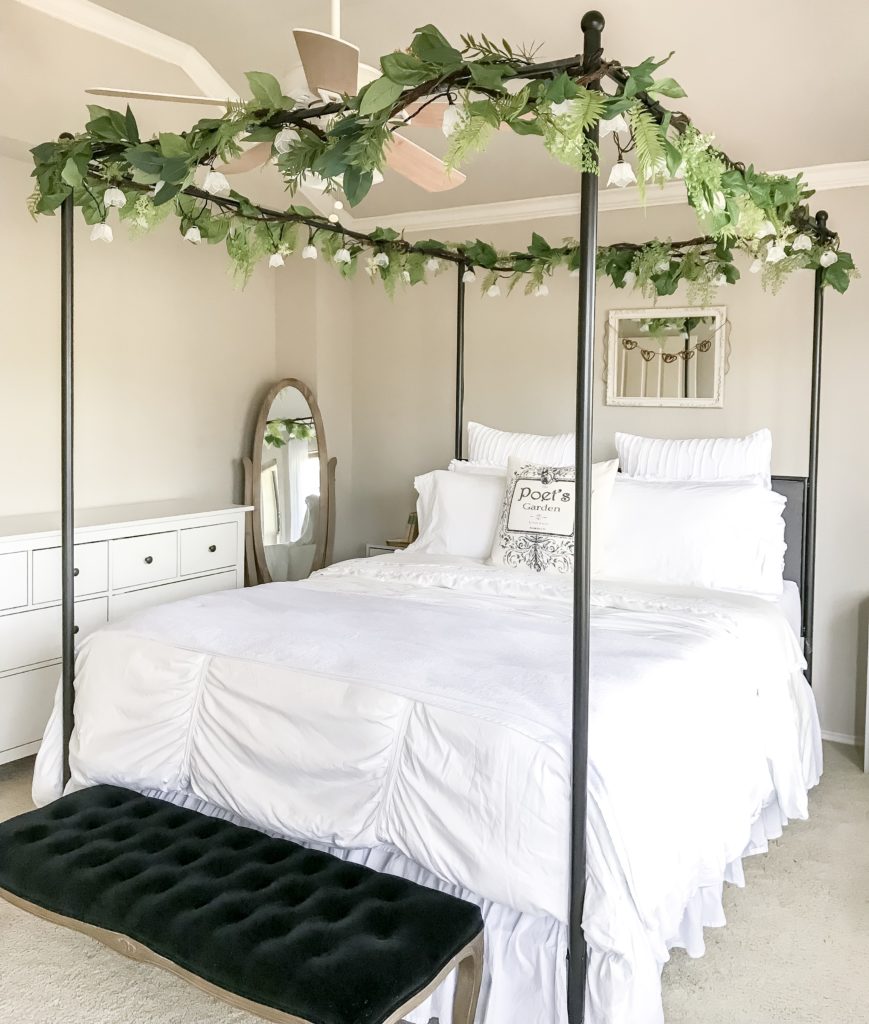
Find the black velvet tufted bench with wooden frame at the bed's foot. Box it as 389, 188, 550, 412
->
0, 785, 483, 1024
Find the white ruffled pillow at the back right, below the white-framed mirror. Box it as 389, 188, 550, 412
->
615, 429, 773, 487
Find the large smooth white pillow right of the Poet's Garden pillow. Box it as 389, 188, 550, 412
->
601, 476, 786, 599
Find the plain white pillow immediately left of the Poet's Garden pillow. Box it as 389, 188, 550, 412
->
405, 469, 505, 558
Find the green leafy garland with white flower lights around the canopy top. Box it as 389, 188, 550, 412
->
29, 25, 857, 294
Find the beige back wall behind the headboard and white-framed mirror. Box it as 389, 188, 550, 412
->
300, 189, 869, 736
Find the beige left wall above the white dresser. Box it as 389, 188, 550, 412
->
0, 159, 275, 516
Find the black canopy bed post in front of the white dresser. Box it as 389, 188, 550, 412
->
60, 196, 76, 786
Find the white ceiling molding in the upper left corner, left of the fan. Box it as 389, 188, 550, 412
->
17, 0, 238, 99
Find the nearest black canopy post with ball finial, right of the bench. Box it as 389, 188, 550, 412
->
567, 10, 605, 1024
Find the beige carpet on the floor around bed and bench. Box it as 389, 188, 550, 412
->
0, 744, 869, 1024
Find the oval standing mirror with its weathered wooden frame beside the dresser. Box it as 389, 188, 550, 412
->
252, 378, 331, 583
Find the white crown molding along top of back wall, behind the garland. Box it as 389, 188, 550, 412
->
344, 160, 869, 233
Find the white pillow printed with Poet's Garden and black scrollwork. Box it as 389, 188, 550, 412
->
491, 456, 618, 575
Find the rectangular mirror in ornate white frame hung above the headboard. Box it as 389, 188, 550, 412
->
606, 306, 727, 409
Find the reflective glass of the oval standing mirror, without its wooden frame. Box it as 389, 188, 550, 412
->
259, 387, 320, 583
